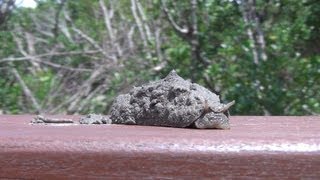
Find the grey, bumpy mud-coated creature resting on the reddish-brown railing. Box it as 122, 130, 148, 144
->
110, 70, 234, 129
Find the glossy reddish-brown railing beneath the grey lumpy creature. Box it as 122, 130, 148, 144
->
0, 115, 320, 179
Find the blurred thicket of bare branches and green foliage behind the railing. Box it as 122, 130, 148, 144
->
0, 0, 320, 115
